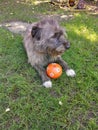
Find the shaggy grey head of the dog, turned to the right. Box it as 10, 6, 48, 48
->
31, 19, 70, 55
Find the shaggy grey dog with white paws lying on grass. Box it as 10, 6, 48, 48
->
24, 19, 75, 88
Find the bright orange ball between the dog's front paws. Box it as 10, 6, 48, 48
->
46, 63, 62, 79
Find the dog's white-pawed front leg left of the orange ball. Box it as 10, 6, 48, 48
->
34, 65, 52, 88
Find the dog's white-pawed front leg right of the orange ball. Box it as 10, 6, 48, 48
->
57, 57, 76, 77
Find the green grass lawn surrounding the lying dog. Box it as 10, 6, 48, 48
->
0, 0, 98, 130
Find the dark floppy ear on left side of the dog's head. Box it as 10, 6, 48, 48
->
31, 26, 41, 40
